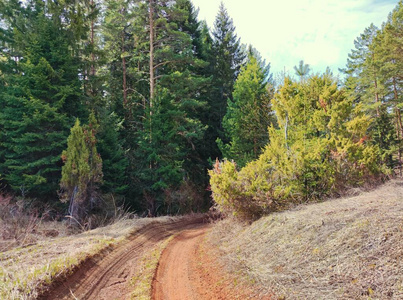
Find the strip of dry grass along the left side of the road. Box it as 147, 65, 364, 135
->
0, 217, 181, 299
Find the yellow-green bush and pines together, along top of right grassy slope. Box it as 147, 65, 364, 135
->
210, 1, 403, 219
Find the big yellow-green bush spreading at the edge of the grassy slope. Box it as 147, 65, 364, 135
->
210, 75, 388, 219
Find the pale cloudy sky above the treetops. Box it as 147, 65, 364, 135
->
193, 0, 399, 75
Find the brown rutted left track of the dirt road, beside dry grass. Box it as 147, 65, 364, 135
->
39, 216, 206, 300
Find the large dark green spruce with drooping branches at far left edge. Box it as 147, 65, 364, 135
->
0, 1, 83, 199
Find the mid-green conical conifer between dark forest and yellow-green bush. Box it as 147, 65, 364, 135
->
218, 53, 273, 166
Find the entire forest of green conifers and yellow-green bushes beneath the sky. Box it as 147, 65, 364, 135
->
0, 0, 403, 220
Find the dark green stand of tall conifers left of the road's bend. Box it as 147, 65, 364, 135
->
0, 0, 246, 217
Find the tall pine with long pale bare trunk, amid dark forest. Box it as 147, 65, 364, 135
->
101, 0, 208, 214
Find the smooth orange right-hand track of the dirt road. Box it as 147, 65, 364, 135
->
151, 226, 270, 300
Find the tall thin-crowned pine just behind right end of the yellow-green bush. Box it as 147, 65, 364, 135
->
344, 24, 401, 166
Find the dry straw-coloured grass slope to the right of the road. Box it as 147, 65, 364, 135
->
209, 181, 403, 299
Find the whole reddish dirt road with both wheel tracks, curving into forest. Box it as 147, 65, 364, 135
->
40, 217, 262, 300
